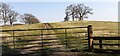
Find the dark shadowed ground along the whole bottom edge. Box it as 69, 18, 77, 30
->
2, 45, 120, 56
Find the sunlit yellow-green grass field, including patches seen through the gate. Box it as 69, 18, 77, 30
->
0, 21, 120, 56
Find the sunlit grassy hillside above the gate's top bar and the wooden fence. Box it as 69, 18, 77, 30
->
0, 21, 120, 36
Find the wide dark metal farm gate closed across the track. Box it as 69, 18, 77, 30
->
1, 25, 92, 56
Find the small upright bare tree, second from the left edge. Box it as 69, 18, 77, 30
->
8, 10, 19, 25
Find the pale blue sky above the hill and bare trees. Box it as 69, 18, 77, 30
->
2, 0, 118, 22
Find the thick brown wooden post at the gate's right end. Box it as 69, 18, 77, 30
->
87, 25, 93, 51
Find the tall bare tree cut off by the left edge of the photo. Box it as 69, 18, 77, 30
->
0, 2, 11, 25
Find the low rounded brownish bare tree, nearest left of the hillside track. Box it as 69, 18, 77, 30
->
20, 13, 39, 24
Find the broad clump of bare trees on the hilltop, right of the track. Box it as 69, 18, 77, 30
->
65, 4, 93, 21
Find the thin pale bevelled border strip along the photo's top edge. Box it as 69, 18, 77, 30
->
1, 0, 119, 2
